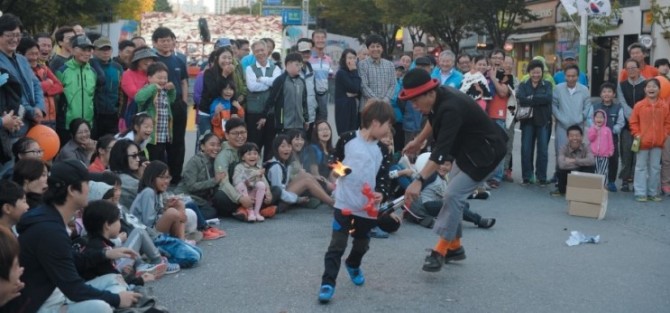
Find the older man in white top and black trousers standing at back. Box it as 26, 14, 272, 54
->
242, 40, 281, 160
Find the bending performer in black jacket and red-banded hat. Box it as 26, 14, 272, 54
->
399, 69, 507, 272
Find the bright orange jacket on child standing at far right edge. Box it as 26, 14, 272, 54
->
628, 98, 670, 150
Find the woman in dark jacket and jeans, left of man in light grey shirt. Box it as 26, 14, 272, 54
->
516, 60, 552, 185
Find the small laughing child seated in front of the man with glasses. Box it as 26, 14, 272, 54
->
233, 142, 272, 222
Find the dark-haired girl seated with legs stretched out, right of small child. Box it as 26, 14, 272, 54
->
265, 135, 334, 213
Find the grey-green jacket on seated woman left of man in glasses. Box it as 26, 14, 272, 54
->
177, 152, 219, 206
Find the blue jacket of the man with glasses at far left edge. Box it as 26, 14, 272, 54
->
0, 52, 44, 126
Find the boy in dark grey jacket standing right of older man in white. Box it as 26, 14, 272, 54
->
259, 53, 309, 133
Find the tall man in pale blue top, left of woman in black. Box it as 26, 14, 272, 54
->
309, 29, 333, 120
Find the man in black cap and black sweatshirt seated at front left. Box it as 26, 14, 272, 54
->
3, 160, 140, 312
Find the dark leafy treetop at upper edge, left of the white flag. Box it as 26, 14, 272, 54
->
465, 0, 537, 48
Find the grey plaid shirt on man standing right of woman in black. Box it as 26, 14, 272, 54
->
358, 57, 396, 106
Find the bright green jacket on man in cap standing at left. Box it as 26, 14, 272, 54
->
56, 59, 97, 129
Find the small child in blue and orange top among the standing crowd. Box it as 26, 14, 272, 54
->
209, 80, 244, 140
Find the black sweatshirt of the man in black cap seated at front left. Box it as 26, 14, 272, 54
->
7, 205, 120, 312
